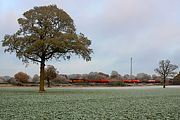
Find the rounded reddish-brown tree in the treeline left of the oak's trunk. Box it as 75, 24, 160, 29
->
14, 72, 29, 83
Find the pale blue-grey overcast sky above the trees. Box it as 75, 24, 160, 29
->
0, 0, 180, 76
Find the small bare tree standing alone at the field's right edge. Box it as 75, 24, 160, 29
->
154, 60, 178, 88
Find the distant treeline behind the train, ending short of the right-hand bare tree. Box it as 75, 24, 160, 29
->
0, 70, 160, 83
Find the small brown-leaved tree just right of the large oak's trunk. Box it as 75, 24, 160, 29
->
45, 65, 58, 87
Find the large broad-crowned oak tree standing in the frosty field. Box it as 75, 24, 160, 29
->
2, 5, 92, 91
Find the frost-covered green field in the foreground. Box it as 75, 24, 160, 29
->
0, 88, 180, 120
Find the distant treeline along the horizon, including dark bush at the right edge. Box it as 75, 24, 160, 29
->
0, 65, 180, 87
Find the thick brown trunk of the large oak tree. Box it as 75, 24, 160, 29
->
39, 61, 45, 92
